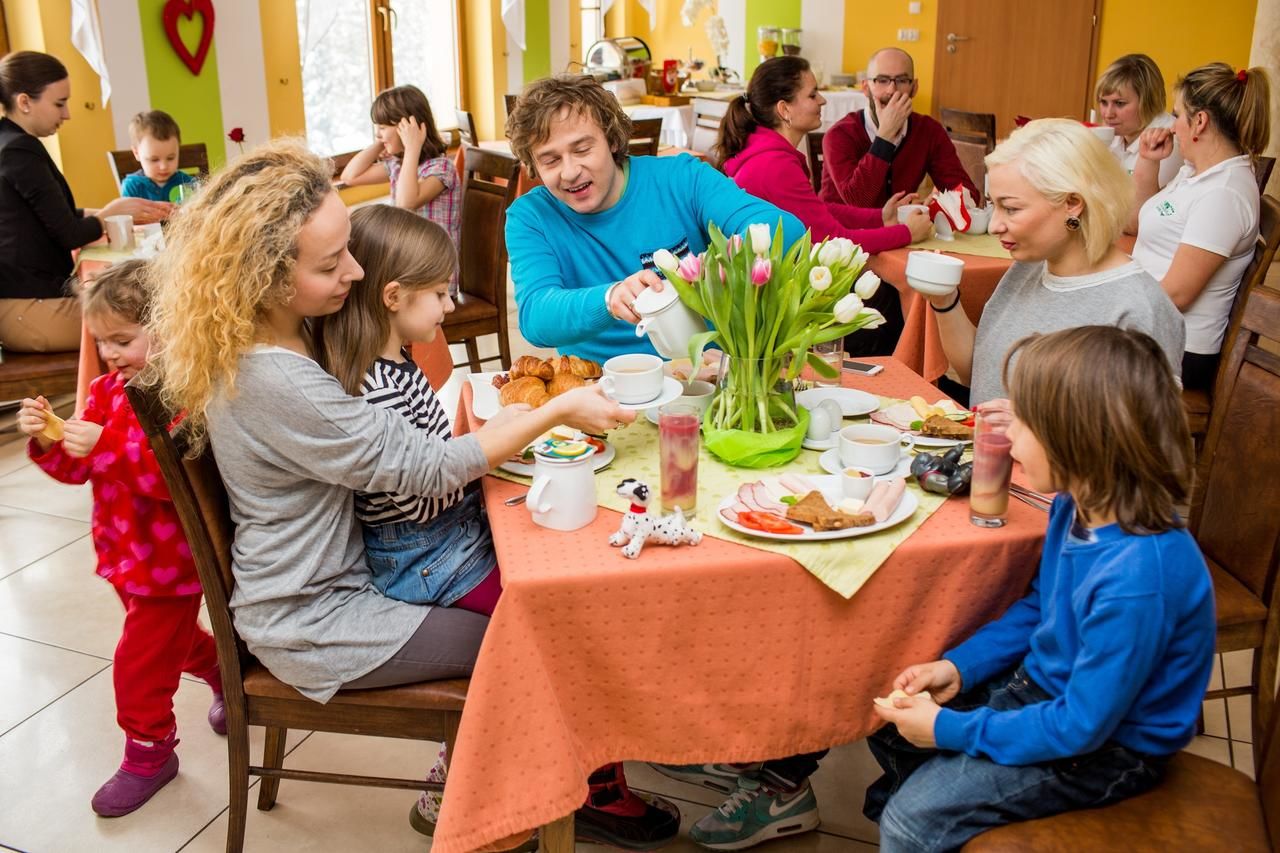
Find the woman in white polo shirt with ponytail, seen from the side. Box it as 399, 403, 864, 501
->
1133, 63, 1271, 389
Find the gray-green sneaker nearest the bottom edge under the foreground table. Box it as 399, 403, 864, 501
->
689, 776, 822, 850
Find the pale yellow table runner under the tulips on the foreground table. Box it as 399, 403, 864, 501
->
493, 397, 946, 598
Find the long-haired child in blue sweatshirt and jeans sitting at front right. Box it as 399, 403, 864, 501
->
863, 327, 1216, 852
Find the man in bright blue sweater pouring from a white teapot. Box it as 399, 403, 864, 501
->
507, 76, 804, 361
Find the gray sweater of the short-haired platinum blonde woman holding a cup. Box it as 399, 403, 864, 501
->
969, 261, 1187, 406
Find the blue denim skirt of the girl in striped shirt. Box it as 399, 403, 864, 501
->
365, 489, 498, 607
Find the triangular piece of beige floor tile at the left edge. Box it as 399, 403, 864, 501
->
0, 634, 109, 734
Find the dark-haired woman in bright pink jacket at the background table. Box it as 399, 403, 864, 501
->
713, 56, 929, 254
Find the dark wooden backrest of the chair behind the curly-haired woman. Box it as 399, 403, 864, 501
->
124, 378, 252, 699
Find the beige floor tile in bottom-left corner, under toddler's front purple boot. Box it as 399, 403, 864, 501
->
0, 670, 294, 852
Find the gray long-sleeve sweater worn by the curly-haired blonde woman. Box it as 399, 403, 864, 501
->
209, 347, 489, 702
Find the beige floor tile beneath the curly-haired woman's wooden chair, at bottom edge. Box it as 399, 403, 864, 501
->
183, 733, 436, 853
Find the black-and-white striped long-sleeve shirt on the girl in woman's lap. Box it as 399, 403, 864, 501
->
356, 351, 462, 525
